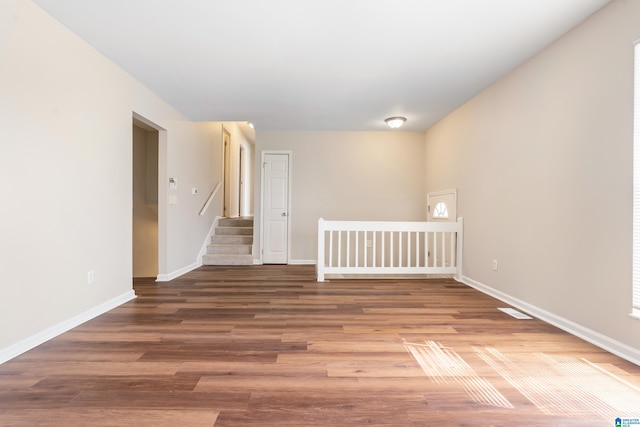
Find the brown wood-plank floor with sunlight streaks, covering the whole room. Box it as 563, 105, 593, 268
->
0, 266, 640, 427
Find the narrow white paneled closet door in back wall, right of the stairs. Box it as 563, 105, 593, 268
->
262, 153, 289, 264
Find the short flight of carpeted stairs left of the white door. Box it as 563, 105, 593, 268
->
202, 217, 253, 265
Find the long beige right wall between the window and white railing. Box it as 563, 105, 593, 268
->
425, 0, 640, 360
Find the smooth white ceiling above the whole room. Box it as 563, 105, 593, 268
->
34, 0, 609, 130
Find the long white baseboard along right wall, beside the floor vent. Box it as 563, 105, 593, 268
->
459, 276, 640, 366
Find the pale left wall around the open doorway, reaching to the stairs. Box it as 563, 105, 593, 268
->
0, 0, 220, 360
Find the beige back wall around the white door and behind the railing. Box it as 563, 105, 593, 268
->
254, 130, 426, 263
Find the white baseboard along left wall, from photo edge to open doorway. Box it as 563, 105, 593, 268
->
0, 290, 136, 364
